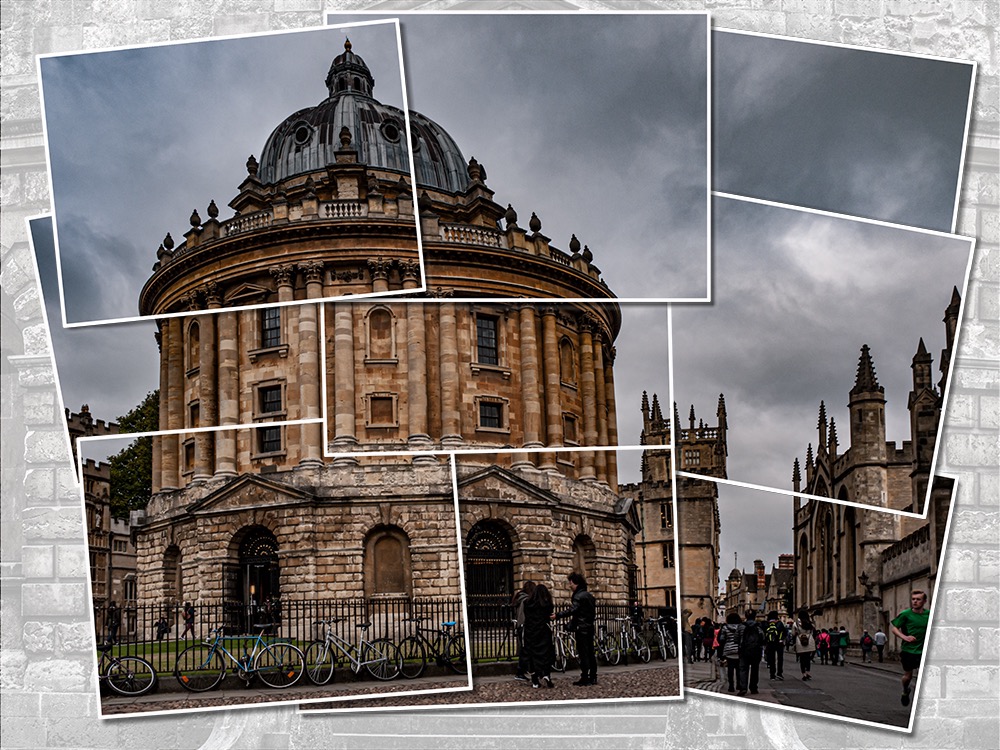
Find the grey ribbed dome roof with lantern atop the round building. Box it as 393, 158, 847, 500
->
258, 40, 468, 193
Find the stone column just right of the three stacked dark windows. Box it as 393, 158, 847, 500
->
298, 260, 324, 466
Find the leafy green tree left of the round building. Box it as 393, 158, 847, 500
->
108, 390, 160, 518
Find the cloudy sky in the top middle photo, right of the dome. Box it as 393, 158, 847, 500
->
329, 13, 708, 299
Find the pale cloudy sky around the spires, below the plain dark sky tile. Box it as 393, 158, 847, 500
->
673, 198, 971, 508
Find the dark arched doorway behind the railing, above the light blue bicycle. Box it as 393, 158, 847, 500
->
224, 526, 281, 633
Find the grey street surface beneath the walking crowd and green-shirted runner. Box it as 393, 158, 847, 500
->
684, 654, 912, 726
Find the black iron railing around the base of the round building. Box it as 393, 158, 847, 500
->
94, 597, 663, 672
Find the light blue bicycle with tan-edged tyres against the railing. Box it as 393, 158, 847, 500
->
174, 624, 305, 693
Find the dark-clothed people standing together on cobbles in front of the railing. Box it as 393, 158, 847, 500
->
511, 573, 597, 688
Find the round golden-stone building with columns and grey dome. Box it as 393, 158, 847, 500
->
135, 42, 637, 624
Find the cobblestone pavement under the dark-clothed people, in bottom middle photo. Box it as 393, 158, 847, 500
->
303, 661, 680, 710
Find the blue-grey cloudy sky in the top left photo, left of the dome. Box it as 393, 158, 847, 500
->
41, 24, 403, 322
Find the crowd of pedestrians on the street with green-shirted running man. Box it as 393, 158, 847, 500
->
691, 589, 930, 706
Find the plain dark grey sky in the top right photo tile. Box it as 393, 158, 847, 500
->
712, 31, 972, 232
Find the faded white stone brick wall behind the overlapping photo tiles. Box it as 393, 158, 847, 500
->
0, 0, 1000, 749
